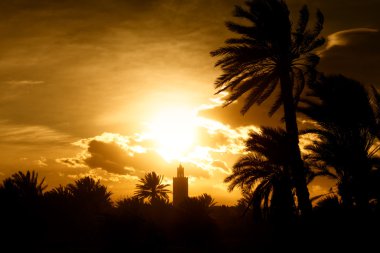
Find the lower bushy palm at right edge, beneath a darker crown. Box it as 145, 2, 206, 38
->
305, 126, 379, 208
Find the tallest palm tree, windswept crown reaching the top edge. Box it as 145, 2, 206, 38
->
211, 0, 325, 215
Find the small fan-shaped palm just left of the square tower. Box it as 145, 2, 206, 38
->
135, 171, 170, 204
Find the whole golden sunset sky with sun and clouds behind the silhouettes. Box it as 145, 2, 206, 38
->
0, 0, 380, 204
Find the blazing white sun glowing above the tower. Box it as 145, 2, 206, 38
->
148, 108, 197, 162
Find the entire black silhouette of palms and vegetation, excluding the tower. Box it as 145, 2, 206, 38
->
0, 0, 380, 252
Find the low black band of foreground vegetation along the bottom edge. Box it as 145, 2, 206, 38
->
0, 172, 380, 252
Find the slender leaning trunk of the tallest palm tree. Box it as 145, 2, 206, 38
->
280, 68, 312, 217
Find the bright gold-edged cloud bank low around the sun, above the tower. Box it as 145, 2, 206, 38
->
56, 106, 258, 178
